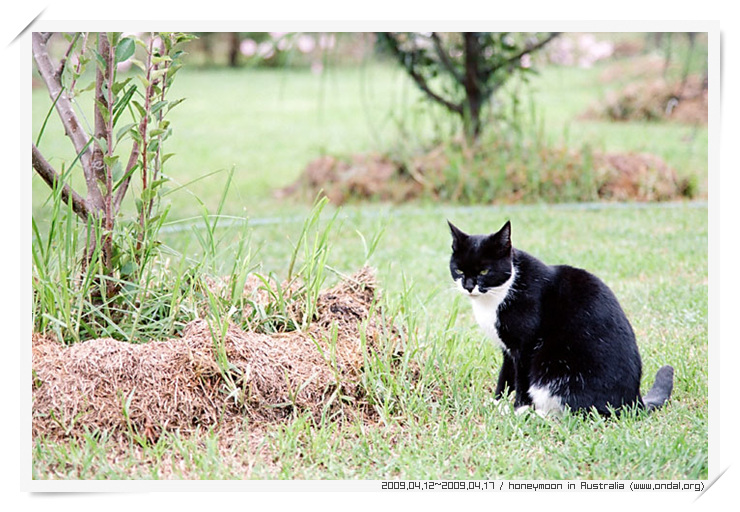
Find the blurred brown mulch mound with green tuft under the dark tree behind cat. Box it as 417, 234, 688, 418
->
277, 146, 694, 205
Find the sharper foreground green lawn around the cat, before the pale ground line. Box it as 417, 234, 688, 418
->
33, 201, 708, 479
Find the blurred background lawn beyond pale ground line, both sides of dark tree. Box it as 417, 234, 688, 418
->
32, 58, 708, 219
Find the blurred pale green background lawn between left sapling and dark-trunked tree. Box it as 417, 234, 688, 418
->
33, 64, 448, 218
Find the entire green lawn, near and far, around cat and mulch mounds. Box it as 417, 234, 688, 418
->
32, 34, 708, 479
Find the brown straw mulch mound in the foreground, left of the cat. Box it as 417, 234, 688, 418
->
32, 268, 396, 440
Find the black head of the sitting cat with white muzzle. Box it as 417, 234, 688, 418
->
447, 221, 513, 296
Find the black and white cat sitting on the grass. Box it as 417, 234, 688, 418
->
448, 221, 673, 415
